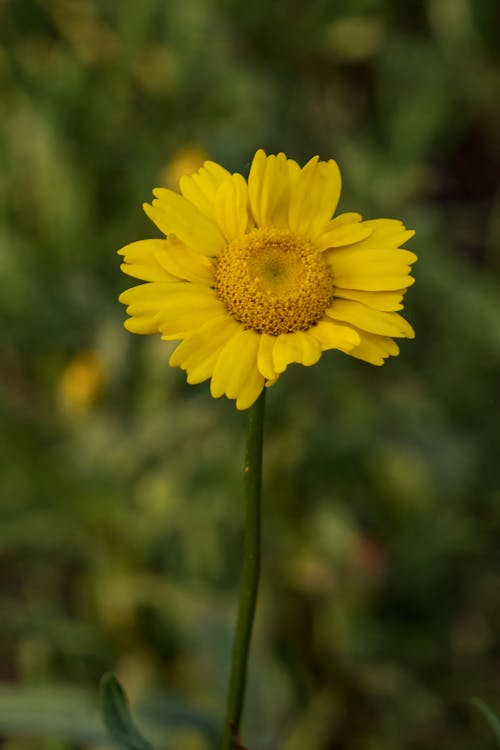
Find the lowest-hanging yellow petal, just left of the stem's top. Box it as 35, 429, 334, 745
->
210, 326, 264, 408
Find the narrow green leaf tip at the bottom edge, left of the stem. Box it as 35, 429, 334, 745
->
101, 673, 153, 750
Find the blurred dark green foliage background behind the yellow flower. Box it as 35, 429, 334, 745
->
0, 0, 500, 750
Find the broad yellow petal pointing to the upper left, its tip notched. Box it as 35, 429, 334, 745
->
144, 188, 225, 255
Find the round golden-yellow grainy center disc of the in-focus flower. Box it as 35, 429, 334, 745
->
215, 229, 333, 336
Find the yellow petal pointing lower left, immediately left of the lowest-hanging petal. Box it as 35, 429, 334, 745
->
169, 314, 240, 384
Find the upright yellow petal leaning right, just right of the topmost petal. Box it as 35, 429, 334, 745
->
288, 156, 341, 240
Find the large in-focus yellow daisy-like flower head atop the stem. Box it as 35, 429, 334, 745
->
119, 150, 416, 409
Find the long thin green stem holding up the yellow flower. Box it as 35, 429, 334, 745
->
222, 389, 265, 750
